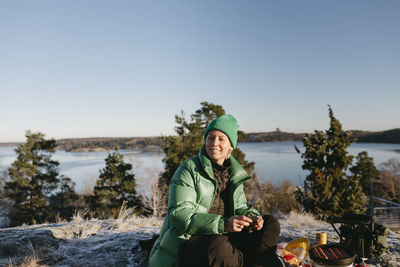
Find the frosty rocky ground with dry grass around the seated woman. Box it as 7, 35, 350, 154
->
0, 213, 400, 267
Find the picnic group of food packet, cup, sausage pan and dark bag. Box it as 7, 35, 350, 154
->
276, 217, 388, 267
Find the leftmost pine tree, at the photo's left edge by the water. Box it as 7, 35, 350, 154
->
5, 131, 59, 225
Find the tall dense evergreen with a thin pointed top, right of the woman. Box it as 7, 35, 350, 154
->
296, 106, 365, 219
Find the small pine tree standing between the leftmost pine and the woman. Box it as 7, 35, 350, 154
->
89, 147, 143, 218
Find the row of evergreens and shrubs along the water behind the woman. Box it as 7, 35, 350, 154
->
0, 102, 400, 228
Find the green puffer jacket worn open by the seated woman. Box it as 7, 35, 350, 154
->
149, 147, 259, 267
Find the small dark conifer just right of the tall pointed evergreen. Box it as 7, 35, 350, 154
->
350, 151, 380, 195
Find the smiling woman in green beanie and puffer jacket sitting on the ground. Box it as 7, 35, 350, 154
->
149, 115, 282, 267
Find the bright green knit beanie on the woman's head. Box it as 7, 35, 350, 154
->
204, 114, 238, 148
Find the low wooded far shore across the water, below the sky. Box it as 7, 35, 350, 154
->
0, 128, 400, 152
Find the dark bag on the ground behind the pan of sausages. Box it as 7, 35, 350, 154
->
331, 213, 389, 258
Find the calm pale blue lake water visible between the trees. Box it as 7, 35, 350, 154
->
0, 142, 400, 198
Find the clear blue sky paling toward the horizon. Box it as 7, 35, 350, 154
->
0, 0, 400, 142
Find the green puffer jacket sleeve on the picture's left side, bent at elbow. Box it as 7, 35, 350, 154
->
168, 162, 224, 235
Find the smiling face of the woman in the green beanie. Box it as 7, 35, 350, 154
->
206, 130, 233, 165
